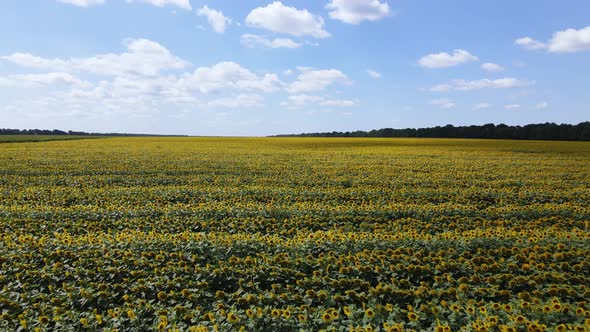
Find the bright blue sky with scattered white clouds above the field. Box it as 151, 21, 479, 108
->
0, 0, 590, 136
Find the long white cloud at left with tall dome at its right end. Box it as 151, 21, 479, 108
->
0, 39, 188, 76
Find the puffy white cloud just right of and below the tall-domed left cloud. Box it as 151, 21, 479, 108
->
179, 62, 283, 94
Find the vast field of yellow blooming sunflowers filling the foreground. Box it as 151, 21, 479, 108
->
0, 137, 590, 331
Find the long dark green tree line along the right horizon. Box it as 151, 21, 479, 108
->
277, 121, 590, 141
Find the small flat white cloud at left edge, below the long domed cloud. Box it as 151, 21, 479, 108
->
0, 72, 91, 88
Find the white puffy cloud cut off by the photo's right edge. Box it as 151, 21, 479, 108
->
514, 26, 590, 53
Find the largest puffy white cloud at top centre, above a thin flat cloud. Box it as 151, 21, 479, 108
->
246, 1, 330, 38
